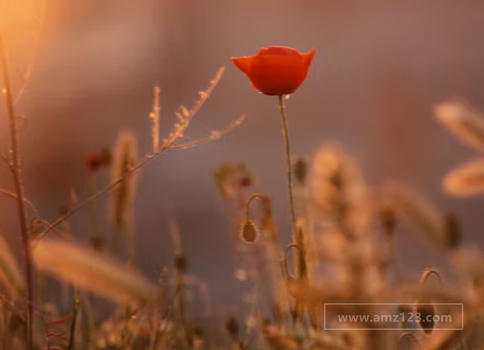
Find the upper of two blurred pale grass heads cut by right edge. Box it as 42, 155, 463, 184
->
434, 102, 484, 151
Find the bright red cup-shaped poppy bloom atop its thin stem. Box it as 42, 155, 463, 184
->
232, 46, 316, 95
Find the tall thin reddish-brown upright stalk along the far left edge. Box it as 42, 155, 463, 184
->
0, 28, 33, 349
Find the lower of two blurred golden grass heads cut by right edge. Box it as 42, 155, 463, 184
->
442, 160, 484, 198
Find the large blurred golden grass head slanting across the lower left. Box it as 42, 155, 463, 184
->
33, 239, 157, 303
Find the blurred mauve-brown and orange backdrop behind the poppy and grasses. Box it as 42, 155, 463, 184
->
0, 0, 484, 314
